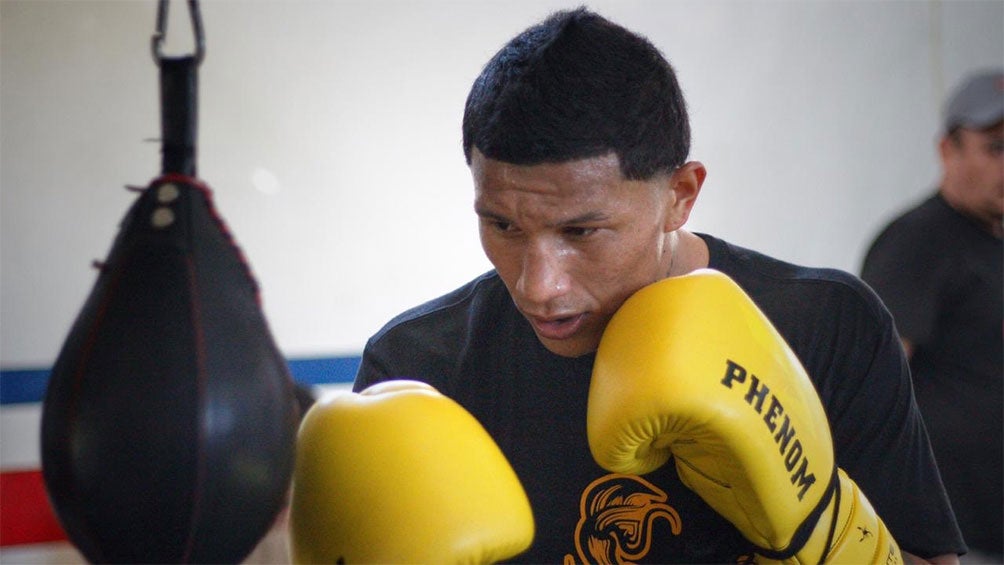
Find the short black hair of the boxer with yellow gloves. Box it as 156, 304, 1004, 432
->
463, 8, 690, 180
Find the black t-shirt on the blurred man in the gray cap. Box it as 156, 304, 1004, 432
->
861, 194, 1004, 555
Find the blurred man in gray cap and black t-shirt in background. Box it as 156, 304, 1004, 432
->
861, 69, 1004, 563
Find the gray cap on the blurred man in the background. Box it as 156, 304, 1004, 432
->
945, 69, 1004, 131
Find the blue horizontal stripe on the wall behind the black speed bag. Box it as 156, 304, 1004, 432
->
0, 356, 361, 404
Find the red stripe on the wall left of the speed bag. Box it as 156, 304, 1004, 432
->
0, 471, 66, 546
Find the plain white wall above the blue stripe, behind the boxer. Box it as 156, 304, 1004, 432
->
0, 0, 1004, 368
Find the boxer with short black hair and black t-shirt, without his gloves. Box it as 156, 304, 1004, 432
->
345, 9, 965, 564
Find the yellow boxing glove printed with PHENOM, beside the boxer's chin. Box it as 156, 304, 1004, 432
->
587, 269, 903, 564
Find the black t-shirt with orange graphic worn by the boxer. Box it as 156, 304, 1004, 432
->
354, 235, 964, 563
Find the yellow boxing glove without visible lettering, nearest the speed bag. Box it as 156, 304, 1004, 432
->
289, 380, 533, 564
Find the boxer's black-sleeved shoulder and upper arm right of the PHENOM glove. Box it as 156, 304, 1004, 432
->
702, 236, 961, 553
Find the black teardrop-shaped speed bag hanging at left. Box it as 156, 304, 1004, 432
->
41, 175, 300, 563
